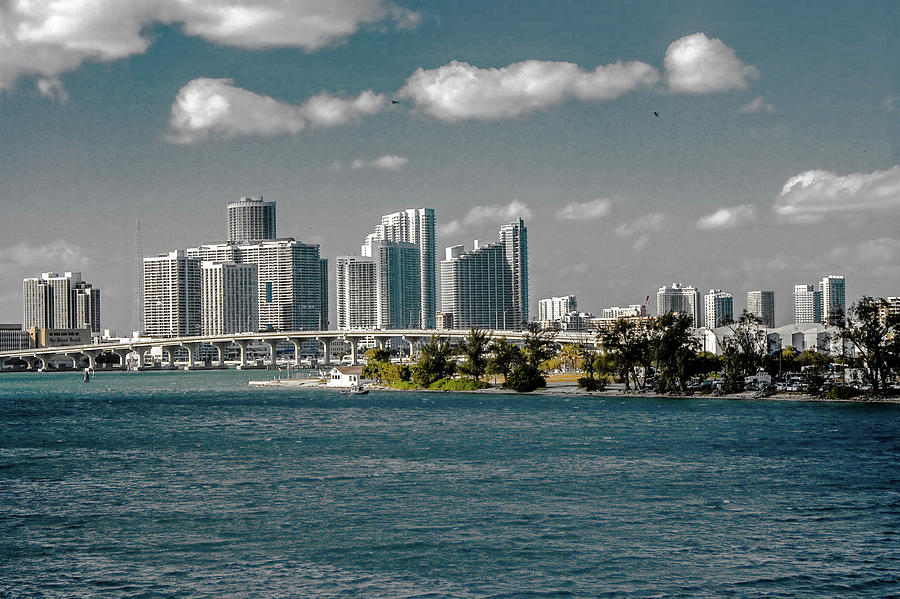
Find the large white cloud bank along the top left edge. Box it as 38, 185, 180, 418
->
0, 0, 419, 89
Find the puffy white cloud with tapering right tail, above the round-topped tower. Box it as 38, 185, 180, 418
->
167, 78, 387, 144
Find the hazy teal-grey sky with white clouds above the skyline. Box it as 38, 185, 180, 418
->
0, 0, 900, 333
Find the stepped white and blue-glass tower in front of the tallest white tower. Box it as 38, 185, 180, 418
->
336, 241, 421, 329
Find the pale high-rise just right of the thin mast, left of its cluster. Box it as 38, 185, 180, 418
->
144, 250, 203, 337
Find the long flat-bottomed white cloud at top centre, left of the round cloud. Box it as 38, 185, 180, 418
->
397, 60, 659, 121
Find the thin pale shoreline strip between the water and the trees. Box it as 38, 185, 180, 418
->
249, 378, 900, 404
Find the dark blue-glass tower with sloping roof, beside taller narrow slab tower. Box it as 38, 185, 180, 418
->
441, 242, 510, 329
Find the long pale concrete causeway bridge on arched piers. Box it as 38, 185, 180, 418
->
0, 329, 597, 370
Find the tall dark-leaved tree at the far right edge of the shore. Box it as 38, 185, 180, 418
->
838, 296, 900, 395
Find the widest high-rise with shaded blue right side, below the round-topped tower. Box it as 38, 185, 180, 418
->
189, 238, 328, 331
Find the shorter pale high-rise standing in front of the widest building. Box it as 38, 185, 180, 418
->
200, 262, 259, 335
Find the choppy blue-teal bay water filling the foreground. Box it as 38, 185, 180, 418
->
0, 371, 900, 597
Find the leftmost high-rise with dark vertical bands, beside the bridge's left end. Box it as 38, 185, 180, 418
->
22, 272, 100, 333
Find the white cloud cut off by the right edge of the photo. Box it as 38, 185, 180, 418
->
773, 165, 900, 222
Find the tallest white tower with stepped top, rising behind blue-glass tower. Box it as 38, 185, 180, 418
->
362, 208, 437, 329
